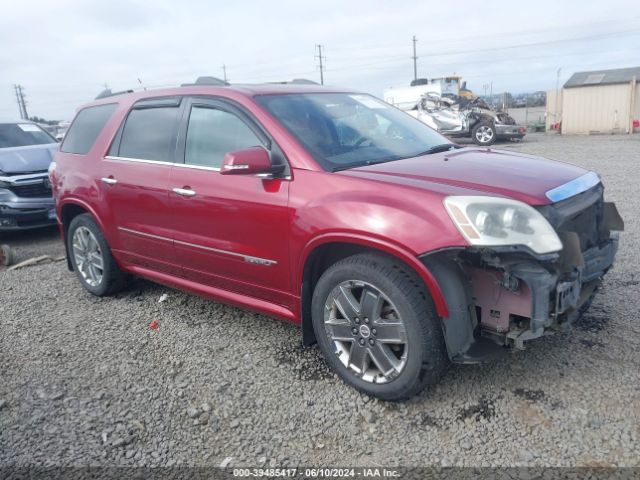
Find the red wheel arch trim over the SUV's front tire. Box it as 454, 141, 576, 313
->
296, 234, 449, 345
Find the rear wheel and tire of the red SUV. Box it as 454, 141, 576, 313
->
67, 213, 128, 297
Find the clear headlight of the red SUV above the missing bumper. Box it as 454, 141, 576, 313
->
444, 196, 562, 254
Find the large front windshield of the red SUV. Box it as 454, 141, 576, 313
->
256, 93, 454, 171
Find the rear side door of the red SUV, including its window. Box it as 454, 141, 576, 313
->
101, 97, 184, 275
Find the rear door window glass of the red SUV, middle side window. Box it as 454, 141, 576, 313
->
118, 107, 179, 162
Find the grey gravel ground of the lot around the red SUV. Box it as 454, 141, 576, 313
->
0, 135, 640, 466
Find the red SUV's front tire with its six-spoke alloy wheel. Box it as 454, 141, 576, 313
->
312, 254, 447, 400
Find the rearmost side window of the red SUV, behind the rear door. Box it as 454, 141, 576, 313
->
60, 103, 118, 154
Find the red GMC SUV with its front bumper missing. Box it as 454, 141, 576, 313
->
50, 84, 623, 400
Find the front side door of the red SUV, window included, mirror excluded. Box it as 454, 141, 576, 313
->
169, 99, 292, 308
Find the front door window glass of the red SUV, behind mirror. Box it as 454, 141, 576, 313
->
185, 107, 262, 168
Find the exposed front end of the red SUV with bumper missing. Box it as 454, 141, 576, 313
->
422, 184, 624, 363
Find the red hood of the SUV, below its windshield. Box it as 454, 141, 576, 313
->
341, 148, 587, 205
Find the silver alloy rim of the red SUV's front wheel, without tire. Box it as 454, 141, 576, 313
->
324, 280, 408, 383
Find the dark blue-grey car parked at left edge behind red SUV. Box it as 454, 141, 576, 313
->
0, 120, 58, 232
